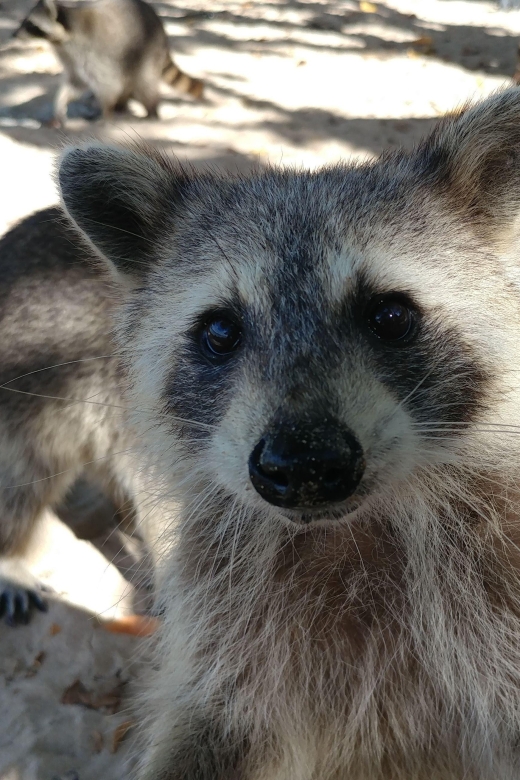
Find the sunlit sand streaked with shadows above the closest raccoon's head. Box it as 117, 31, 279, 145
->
0, 0, 520, 235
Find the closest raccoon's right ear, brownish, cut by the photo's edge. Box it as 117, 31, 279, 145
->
417, 88, 520, 243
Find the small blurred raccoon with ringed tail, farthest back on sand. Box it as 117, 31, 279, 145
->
14, 0, 203, 126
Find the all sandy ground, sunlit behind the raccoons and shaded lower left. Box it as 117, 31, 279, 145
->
0, 0, 520, 780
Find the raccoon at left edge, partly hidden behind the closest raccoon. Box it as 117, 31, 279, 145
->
0, 208, 170, 625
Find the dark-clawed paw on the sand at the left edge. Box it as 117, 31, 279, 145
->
0, 557, 48, 626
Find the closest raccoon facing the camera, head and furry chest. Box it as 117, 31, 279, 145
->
59, 90, 520, 780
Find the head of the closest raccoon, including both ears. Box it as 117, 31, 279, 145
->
59, 90, 520, 523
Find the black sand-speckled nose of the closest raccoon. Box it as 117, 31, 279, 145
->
249, 420, 365, 509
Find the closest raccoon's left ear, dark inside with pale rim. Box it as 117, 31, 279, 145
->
58, 144, 182, 284
